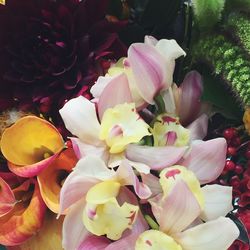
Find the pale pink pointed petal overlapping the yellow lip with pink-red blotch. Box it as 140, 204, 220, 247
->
153, 180, 201, 234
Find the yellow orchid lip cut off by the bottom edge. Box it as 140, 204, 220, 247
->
135, 230, 182, 250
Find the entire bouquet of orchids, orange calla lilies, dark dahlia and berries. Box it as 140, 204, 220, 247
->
0, 0, 250, 250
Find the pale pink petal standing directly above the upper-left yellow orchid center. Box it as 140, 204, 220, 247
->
97, 73, 133, 119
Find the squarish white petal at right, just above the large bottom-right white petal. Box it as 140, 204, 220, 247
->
200, 185, 233, 221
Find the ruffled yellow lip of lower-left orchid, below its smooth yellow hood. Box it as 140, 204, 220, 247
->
83, 198, 139, 240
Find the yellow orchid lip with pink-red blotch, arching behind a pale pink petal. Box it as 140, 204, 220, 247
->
160, 165, 204, 209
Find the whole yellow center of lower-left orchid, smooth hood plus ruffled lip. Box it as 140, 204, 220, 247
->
83, 181, 139, 240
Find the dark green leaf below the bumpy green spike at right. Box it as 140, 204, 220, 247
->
202, 70, 243, 120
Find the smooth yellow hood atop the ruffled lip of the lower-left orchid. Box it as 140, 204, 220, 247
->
86, 181, 121, 204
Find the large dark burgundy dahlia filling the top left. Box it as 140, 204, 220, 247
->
0, 0, 126, 114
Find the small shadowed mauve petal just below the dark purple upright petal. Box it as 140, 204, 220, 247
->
187, 114, 208, 141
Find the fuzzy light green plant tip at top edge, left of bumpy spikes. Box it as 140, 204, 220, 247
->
192, 0, 225, 29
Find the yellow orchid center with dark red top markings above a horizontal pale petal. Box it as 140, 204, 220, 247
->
151, 114, 190, 147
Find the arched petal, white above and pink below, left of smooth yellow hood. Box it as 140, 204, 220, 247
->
60, 156, 115, 213
